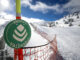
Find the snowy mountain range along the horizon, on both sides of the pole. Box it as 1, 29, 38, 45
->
0, 12, 80, 27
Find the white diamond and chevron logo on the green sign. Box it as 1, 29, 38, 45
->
13, 25, 28, 42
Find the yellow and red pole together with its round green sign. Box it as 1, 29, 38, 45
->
3, 0, 31, 60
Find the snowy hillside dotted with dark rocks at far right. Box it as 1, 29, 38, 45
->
55, 12, 80, 27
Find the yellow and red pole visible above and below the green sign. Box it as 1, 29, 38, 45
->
14, 0, 23, 60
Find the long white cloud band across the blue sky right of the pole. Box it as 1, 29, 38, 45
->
22, 0, 80, 13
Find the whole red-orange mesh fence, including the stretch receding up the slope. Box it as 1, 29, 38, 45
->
13, 23, 58, 60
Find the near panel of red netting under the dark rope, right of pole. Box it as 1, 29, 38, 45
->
23, 45, 53, 60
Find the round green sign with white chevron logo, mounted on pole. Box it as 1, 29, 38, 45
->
4, 20, 31, 48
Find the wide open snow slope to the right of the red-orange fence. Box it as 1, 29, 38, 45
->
40, 26, 80, 60
